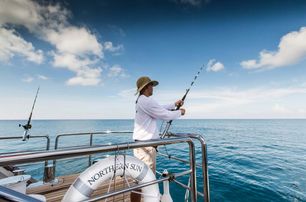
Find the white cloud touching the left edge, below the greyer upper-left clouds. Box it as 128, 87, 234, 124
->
0, 27, 43, 64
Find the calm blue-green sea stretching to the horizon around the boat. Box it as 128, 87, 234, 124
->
0, 120, 306, 202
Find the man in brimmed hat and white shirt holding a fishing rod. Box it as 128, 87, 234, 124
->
131, 76, 185, 201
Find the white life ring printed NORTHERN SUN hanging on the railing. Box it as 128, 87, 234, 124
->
62, 155, 160, 202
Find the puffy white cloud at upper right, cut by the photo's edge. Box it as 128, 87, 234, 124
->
240, 27, 306, 69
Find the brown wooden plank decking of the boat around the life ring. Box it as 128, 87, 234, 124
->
27, 174, 137, 202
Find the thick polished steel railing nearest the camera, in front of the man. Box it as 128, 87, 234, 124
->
0, 137, 197, 202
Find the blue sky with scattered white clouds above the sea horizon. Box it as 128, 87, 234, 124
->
0, 0, 306, 120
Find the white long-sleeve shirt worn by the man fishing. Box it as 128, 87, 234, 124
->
133, 95, 181, 140
